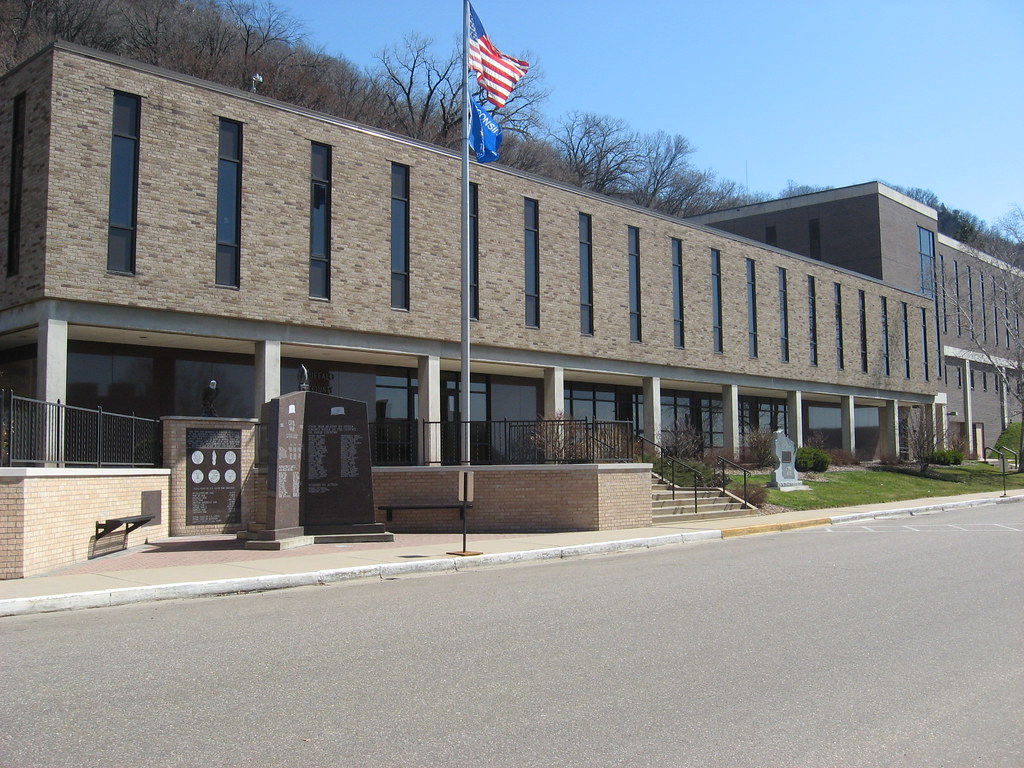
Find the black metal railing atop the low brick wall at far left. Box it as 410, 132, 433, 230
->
0, 391, 162, 467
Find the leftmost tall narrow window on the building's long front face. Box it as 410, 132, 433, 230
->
106, 92, 140, 273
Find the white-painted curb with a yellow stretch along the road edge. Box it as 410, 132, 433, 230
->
0, 497, 1007, 617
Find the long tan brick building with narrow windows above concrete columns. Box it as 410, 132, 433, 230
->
0, 43, 951, 463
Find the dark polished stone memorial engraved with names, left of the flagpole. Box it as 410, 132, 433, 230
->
256, 390, 392, 542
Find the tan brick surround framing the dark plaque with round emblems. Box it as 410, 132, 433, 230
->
163, 418, 260, 536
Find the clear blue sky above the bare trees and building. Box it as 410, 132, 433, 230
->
274, 0, 1024, 223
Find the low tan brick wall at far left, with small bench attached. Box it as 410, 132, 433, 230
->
0, 468, 170, 579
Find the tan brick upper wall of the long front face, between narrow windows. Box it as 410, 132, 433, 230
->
0, 43, 936, 403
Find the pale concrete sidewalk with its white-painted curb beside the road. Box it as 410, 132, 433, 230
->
0, 490, 1024, 616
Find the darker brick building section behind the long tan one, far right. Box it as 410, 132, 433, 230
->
692, 181, 1021, 455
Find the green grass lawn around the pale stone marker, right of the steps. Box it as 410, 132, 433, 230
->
729, 462, 1024, 510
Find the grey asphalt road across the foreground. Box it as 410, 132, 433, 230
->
0, 504, 1024, 768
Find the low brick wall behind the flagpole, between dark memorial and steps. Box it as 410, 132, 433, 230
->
374, 464, 651, 532
